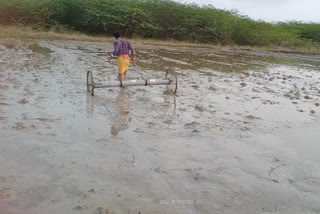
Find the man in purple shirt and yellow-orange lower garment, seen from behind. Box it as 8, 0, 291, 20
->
108, 32, 135, 81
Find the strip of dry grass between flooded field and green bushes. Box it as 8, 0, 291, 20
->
0, 25, 320, 55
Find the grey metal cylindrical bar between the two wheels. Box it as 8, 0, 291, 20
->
94, 79, 172, 88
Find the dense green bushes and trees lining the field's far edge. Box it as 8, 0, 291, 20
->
0, 0, 320, 51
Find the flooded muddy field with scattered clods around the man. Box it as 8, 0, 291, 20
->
0, 40, 320, 214
